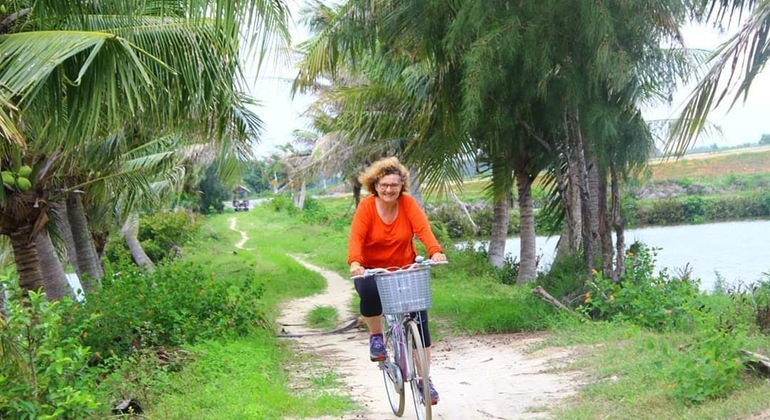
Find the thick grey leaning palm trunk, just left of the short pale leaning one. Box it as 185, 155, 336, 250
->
67, 192, 104, 294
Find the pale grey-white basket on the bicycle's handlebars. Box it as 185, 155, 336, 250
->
374, 267, 432, 314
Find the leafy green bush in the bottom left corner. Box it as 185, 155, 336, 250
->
0, 285, 99, 419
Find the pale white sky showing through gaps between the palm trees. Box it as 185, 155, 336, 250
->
246, 6, 770, 157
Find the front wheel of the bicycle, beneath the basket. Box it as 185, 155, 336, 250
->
406, 321, 432, 420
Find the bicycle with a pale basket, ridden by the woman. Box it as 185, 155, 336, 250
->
353, 257, 446, 420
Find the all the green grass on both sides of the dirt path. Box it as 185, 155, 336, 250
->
149, 199, 770, 419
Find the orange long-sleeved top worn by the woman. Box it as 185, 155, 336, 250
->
348, 194, 442, 268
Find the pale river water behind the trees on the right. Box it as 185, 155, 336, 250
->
492, 220, 770, 290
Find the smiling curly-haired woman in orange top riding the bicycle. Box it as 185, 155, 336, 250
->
348, 157, 446, 404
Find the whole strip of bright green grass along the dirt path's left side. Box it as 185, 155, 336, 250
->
147, 210, 355, 419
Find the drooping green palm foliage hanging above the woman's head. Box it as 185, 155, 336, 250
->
295, 0, 464, 200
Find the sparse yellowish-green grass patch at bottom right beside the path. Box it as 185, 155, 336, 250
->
543, 319, 770, 419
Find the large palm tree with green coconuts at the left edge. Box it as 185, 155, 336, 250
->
0, 0, 288, 296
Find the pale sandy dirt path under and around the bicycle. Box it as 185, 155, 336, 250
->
278, 256, 580, 420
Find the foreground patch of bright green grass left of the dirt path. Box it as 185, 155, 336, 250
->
151, 331, 354, 419
